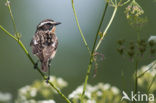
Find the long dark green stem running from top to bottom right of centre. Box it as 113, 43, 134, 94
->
81, 2, 108, 103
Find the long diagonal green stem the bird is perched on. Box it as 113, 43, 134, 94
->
0, 25, 71, 103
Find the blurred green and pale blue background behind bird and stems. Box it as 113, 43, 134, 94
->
0, 0, 156, 101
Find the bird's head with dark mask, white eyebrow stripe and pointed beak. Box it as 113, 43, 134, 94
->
37, 19, 61, 32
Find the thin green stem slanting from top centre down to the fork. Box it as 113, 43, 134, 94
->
71, 0, 91, 54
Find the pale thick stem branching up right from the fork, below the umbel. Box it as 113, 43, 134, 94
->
95, 6, 118, 51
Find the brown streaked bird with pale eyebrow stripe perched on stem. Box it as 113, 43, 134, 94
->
30, 19, 61, 80
